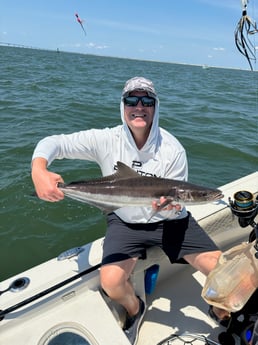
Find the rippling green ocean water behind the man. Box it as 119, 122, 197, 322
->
0, 46, 258, 281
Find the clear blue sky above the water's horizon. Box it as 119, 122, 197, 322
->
0, 0, 258, 70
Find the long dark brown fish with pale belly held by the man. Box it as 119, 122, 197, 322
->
58, 161, 223, 218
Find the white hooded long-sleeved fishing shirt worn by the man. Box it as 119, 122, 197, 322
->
32, 97, 188, 223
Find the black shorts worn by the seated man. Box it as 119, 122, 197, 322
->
102, 213, 218, 265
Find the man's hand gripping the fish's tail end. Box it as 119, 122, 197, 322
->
31, 158, 64, 202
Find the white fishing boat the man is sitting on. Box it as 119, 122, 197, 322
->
0, 171, 258, 345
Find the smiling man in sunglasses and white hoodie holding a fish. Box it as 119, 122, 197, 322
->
32, 77, 228, 344
